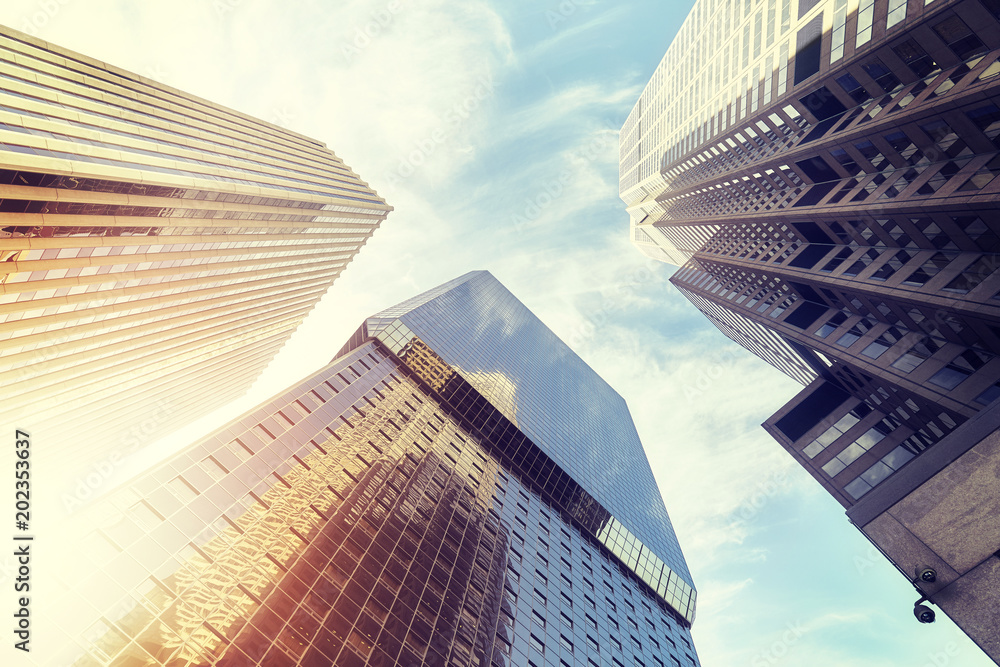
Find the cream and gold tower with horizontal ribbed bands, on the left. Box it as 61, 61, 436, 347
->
0, 27, 391, 481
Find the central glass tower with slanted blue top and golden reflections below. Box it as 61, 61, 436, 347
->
47, 272, 698, 667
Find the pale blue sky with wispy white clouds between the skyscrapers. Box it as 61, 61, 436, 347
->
0, 0, 992, 667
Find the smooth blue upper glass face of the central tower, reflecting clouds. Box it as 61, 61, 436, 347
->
340, 271, 692, 596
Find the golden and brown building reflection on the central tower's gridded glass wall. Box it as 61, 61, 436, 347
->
78, 345, 506, 665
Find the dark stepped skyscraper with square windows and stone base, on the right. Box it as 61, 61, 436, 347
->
620, 0, 1000, 659
